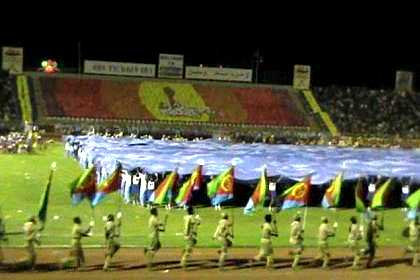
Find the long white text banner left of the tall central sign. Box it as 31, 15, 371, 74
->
84, 60, 156, 77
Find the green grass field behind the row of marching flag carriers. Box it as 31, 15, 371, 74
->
0, 144, 414, 247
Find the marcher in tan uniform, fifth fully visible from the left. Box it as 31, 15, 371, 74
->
181, 206, 201, 269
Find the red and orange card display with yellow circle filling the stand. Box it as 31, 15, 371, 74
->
32, 73, 310, 127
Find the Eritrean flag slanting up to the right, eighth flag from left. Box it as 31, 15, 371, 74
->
282, 176, 311, 210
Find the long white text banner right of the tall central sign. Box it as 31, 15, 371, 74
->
185, 66, 252, 82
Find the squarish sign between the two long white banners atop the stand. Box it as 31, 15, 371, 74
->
158, 53, 184, 79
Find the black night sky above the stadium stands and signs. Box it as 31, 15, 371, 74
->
0, 6, 420, 88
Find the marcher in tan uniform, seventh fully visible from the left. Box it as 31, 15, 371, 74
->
254, 214, 278, 268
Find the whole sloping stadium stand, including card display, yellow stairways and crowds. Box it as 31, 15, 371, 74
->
0, 73, 420, 138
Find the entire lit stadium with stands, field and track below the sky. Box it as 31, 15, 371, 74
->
0, 44, 420, 279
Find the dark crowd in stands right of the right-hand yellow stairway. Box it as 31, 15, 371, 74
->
314, 86, 420, 138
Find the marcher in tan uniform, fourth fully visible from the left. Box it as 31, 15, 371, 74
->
144, 208, 168, 270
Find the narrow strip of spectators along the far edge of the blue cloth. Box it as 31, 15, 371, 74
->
61, 120, 420, 149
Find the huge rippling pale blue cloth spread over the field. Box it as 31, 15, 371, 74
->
68, 136, 420, 184
